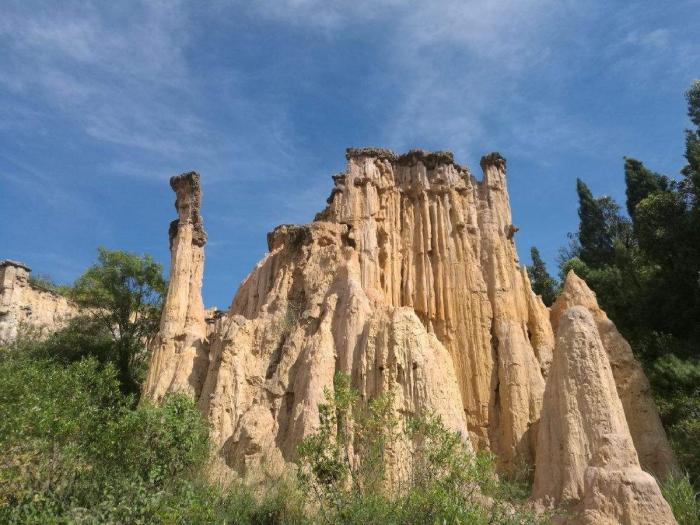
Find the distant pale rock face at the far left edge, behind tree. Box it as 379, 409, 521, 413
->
0, 260, 79, 344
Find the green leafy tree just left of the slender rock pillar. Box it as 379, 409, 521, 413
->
72, 248, 166, 393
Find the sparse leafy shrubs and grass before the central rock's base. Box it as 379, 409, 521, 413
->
299, 374, 547, 524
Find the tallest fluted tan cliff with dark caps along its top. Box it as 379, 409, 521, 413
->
317, 149, 553, 466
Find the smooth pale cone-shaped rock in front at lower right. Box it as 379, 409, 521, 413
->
533, 306, 676, 525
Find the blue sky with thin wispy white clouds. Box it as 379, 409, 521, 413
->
0, 0, 700, 307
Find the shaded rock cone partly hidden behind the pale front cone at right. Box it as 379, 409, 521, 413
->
551, 270, 678, 479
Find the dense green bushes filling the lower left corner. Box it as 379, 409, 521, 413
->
0, 352, 208, 523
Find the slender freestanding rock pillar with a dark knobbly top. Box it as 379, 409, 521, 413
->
143, 172, 208, 400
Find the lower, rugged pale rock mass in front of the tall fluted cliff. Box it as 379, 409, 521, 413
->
199, 222, 468, 476
